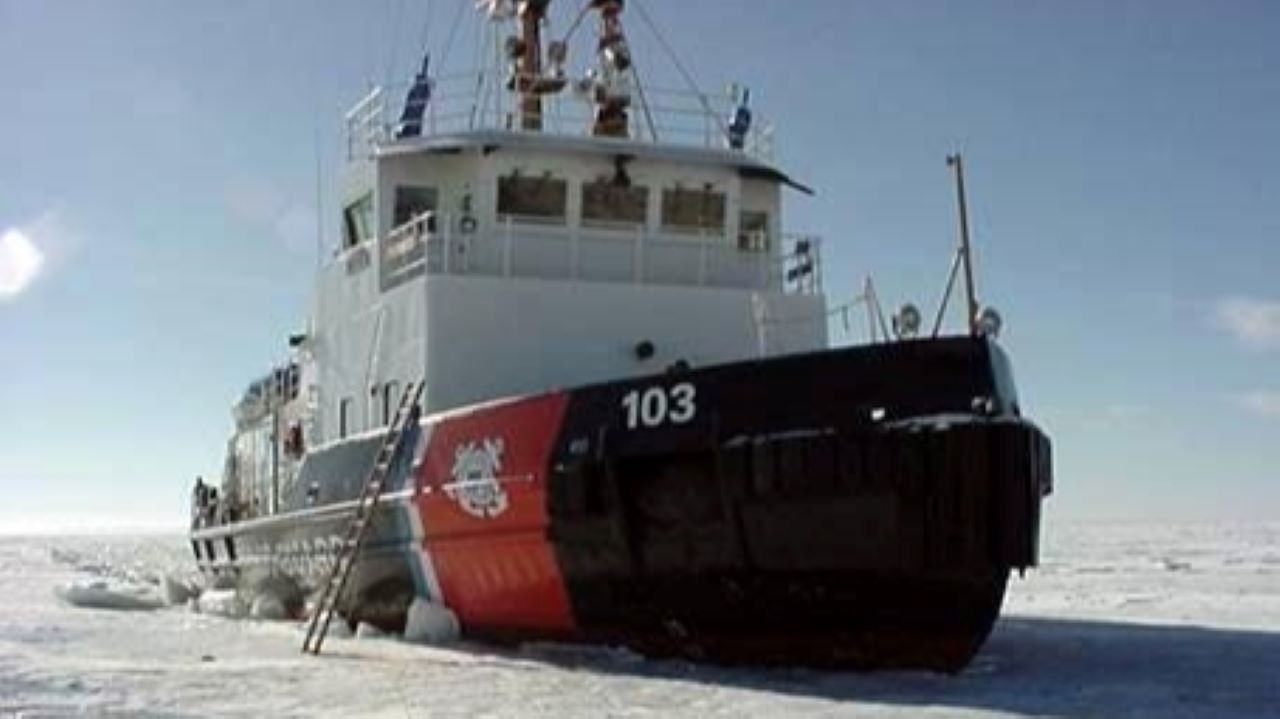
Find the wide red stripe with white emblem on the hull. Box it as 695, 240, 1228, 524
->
417, 394, 575, 632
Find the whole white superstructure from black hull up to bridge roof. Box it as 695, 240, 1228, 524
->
315, 82, 827, 429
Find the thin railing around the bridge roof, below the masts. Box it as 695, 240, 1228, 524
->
346, 73, 774, 160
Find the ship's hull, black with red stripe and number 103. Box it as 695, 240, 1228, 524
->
193, 339, 1051, 670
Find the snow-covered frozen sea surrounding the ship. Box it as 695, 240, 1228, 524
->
0, 523, 1280, 719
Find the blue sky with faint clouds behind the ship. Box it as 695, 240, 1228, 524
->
0, 0, 1280, 532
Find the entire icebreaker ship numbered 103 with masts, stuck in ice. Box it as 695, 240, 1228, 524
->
189, 0, 1052, 672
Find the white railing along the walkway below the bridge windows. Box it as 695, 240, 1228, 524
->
378, 212, 822, 294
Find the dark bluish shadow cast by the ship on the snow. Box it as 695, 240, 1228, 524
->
526, 608, 1280, 719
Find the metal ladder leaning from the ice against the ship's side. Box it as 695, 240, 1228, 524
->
302, 383, 424, 654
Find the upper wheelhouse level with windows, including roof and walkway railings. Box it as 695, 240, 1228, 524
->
340, 82, 822, 299
